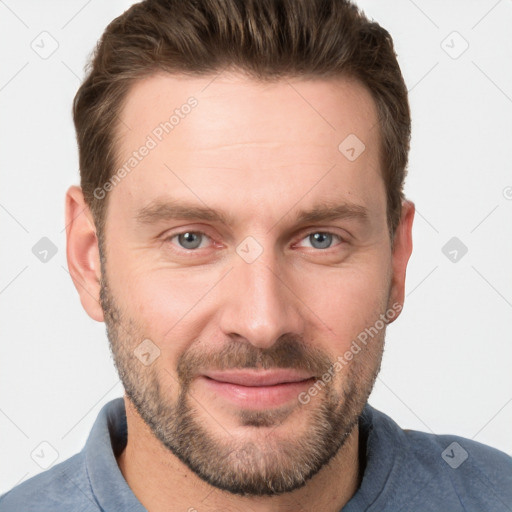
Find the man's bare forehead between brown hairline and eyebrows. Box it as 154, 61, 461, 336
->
111, 73, 384, 228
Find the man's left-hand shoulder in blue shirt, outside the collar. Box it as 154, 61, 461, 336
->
0, 452, 100, 512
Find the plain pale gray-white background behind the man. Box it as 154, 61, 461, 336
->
0, 0, 512, 492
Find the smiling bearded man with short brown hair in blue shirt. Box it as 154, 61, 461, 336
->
0, 0, 512, 512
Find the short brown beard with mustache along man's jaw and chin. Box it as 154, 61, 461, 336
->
100, 272, 384, 496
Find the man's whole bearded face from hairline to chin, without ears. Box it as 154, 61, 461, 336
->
92, 74, 399, 495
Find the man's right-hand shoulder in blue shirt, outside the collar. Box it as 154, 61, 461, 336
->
366, 409, 512, 511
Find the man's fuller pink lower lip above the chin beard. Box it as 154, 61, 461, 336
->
198, 377, 314, 409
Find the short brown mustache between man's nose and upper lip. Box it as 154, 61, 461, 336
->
177, 335, 333, 383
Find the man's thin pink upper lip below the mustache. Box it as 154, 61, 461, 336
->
203, 369, 313, 386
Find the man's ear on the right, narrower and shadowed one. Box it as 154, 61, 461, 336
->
388, 200, 415, 323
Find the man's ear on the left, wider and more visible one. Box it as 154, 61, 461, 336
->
66, 186, 104, 322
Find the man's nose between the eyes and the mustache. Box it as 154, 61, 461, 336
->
220, 245, 304, 348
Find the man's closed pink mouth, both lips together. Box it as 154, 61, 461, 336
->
198, 369, 315, 409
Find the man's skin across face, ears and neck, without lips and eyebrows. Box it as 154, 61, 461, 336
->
66, 73, 414, 512
